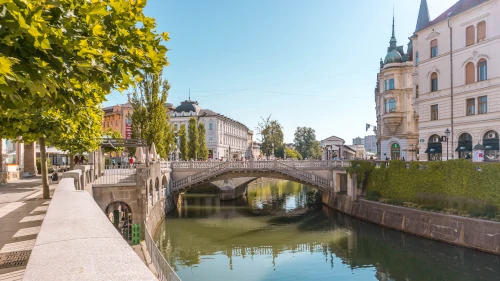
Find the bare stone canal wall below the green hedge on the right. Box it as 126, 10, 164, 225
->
322, 194, 500, 255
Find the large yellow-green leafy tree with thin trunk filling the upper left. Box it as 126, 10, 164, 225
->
0, 0, 168, 199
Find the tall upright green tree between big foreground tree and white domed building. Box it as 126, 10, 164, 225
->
131, 73, 175, 158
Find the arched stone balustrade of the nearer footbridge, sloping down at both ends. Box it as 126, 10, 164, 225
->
172, 161, 332, 191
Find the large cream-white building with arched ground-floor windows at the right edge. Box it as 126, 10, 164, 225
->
411, 0, 500, 161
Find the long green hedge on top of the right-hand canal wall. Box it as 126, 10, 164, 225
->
347, 159, 500, 207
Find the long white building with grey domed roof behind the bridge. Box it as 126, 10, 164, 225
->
170, 100, 253, 160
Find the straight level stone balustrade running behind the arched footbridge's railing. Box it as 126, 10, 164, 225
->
172, 160, 350, 170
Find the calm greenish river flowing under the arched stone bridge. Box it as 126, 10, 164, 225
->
155, 181, 500, 281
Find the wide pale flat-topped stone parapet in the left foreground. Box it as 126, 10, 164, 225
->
24, 178, 158, 281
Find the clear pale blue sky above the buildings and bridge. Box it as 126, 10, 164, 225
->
105, 0, 456, 144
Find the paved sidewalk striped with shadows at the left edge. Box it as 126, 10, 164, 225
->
0, 176, 57, 281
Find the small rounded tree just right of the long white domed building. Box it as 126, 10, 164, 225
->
257, 115, 284, 157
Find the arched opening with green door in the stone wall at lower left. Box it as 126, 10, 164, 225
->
105, 201, 132, 240
